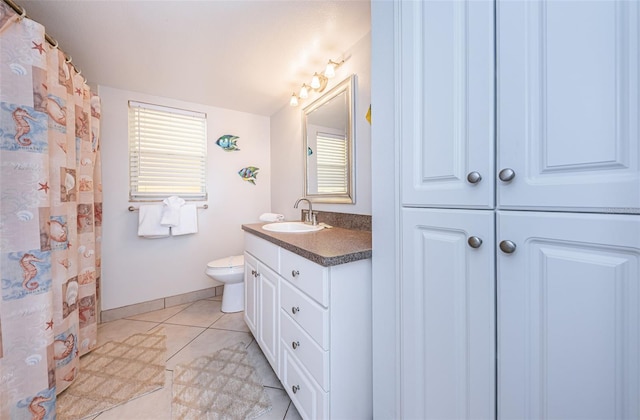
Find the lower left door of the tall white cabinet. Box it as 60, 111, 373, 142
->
400, 209, 495, 419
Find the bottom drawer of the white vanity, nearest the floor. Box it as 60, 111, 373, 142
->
282, 348, 329, 419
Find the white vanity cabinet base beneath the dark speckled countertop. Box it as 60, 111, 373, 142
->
245, 233, 373, 419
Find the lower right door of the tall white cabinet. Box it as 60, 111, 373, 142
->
497, 211, 640, 419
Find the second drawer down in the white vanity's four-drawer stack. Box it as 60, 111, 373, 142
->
280, 281, 329, 350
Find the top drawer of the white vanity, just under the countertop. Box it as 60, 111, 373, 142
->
280, 249, 329, 308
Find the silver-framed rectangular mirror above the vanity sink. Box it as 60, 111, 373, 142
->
302, 74, 356, 203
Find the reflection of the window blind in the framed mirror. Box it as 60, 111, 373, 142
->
316, 132, 349, 193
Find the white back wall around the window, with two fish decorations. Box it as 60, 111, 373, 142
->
98, 86, 272, 310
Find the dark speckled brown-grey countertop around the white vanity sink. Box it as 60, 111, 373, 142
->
242, 223, 371, 267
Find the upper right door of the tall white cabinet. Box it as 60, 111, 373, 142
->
497, 0, 640, 213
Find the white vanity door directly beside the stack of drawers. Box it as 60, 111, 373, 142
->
257, 264, 280, 372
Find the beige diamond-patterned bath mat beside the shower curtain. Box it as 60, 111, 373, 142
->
56, 329, 166, 420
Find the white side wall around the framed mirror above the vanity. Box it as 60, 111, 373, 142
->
271, 34, 375, 220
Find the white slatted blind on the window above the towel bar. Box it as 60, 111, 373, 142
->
129, 101, 207, 201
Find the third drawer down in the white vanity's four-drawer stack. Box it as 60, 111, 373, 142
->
280, 311, 329, 391
